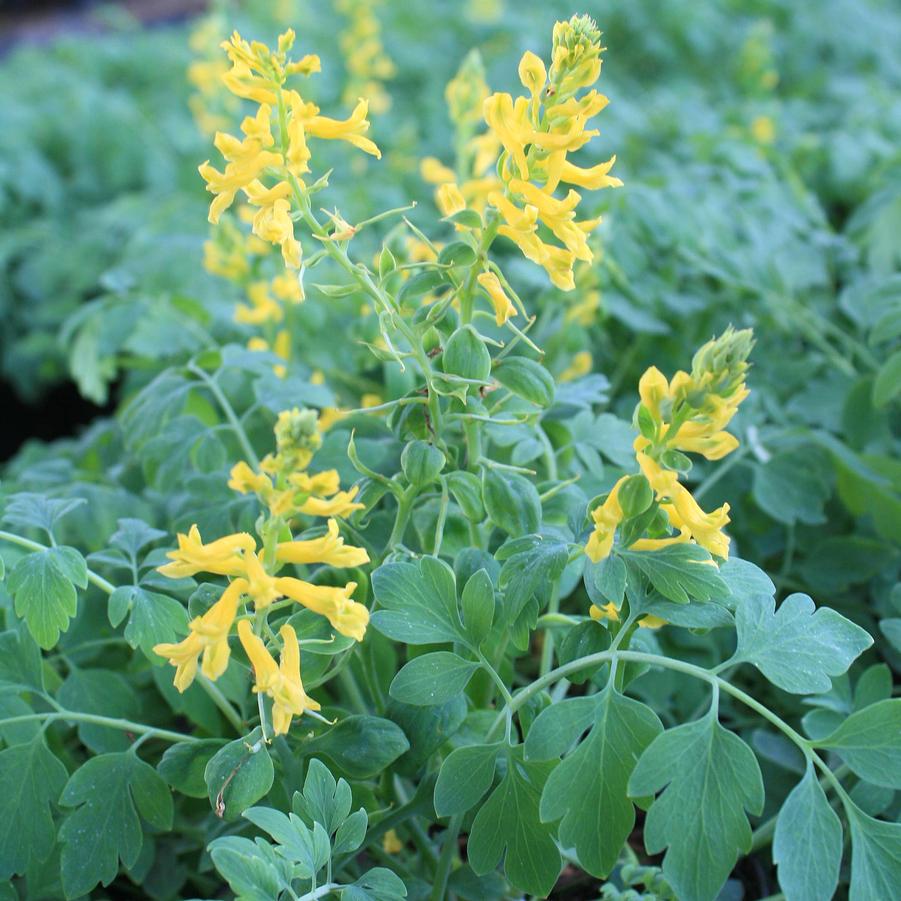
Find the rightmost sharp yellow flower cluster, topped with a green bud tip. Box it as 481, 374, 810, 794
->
585, 328, 753, 562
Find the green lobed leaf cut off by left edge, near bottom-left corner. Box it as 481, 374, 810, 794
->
0, 734, 69, 879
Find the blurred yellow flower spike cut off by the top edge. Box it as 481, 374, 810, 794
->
335, 0, 395, 113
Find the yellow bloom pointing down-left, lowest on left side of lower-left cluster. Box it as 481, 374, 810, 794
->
153, 579, 247, 692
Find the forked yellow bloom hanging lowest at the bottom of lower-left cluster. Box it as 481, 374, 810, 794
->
238, 619, 320, 735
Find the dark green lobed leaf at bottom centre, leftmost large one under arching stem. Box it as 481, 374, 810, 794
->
467, 748, 560, 897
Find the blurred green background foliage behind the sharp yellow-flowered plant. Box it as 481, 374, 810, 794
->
0, 0, 901, 892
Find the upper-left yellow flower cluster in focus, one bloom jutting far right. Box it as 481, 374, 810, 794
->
200, 29, 381, 269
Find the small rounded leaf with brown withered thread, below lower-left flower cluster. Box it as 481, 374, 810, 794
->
203, 728, 275, 820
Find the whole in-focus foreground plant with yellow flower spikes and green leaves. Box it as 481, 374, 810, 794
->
0, 7, 901, 901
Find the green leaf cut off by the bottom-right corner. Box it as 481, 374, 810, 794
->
845, 804, 901, 901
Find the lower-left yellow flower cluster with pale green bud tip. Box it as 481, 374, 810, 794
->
154, 410, 369, 734
